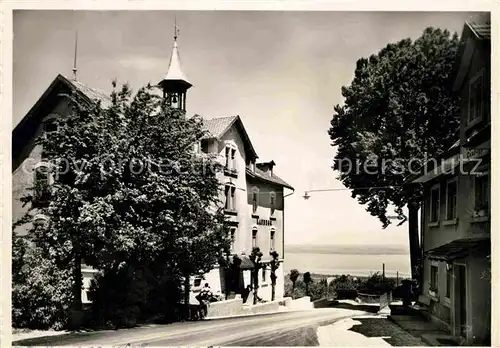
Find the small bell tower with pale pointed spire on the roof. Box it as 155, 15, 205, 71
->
158, 21, 193, 111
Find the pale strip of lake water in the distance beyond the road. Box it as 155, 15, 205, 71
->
284, 251, 410, 278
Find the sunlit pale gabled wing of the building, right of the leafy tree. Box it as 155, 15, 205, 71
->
192, 116, 293, 300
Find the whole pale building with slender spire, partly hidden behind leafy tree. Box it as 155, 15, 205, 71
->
12, 29, 292, 303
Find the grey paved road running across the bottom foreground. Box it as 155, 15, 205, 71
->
13, 308, 367, 347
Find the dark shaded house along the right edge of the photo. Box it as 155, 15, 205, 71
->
413, 17, 491, 343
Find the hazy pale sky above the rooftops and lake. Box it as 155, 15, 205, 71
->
13, 10, 478, 247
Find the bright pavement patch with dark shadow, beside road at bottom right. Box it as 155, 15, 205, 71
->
317, 316, 426, 347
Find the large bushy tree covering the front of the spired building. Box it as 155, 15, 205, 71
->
15, 83, 230, 326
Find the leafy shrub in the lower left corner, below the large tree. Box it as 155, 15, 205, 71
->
12, 236, 73, 330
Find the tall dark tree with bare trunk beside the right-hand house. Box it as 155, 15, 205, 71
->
328, 28, 459, 278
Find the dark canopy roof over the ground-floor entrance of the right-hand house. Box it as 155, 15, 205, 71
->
424, 238, 491, 261
